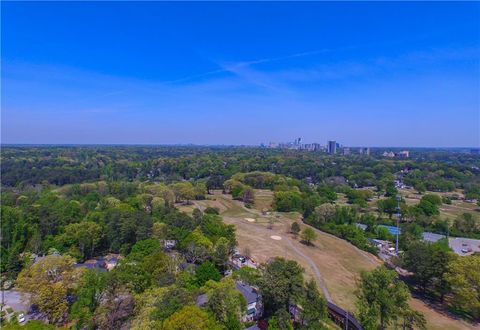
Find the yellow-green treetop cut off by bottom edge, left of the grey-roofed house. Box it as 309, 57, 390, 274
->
163, 306, 221, 330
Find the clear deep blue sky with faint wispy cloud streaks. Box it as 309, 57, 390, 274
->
1, 2, 480, 147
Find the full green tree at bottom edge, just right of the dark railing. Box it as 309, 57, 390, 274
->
356, 266, 410, 329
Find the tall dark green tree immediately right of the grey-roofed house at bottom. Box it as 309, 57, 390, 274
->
259, 257, 303, 316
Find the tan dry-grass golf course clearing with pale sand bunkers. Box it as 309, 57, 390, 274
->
185, 190, 477, 330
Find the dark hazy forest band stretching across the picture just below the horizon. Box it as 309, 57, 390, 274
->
1, 146, 480, 191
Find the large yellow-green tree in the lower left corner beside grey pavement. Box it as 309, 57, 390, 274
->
17, 255, 84, 323
